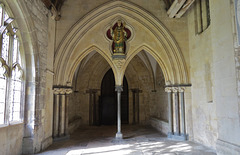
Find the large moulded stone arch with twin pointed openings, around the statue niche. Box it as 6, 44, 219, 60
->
54, 1, 189, 85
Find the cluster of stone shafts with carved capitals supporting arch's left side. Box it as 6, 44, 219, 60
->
53, 86, 72, 140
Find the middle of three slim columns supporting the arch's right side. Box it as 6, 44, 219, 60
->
173, 87, 180, 135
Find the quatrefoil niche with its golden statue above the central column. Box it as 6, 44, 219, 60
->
107, 20, 131, 58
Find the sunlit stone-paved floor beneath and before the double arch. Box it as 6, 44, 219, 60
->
35, 125, 216, 155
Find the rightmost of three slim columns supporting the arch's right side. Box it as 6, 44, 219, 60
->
178, 87, 186, 136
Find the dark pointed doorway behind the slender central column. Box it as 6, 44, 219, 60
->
99, 69, 128, 125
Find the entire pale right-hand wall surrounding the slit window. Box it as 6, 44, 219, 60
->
188, 0, 240, 154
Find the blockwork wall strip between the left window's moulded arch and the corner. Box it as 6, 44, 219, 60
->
23, 0, 52, 153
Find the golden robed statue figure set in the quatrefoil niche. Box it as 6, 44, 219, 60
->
110, 20, 127, 53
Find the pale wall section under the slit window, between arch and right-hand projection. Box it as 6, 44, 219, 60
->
188, 1, 217, 148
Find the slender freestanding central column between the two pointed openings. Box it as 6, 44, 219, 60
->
115, 86, 123, 139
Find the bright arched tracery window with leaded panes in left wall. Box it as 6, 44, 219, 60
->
0, 4, 24, 125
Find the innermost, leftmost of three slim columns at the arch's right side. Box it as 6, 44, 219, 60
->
165, 87, 173, 138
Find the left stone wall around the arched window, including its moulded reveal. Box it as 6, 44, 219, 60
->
0, 0, 51, 155
